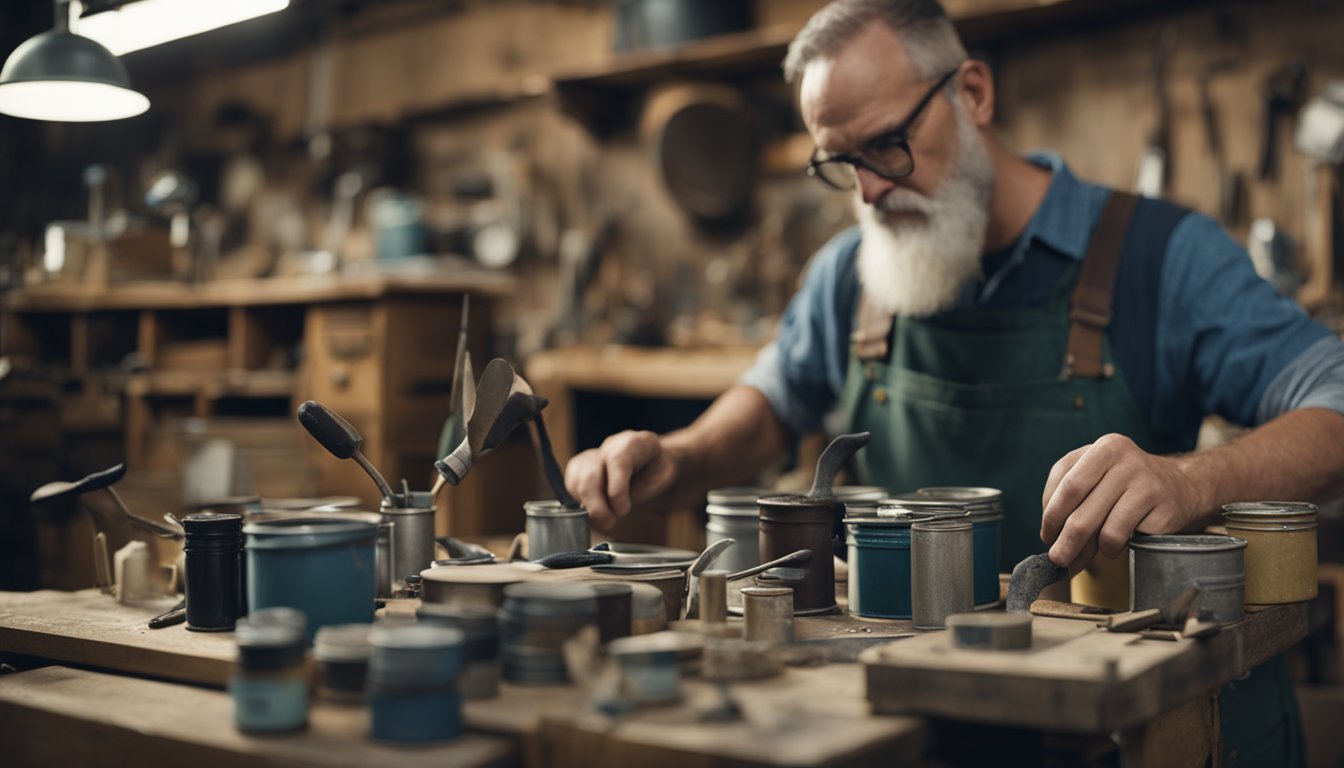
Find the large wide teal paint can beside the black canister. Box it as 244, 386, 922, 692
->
243, 516, 378, 643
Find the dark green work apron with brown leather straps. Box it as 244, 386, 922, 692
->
841, 195, 1302, 765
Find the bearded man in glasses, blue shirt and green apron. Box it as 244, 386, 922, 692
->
566, 0, 1344, 765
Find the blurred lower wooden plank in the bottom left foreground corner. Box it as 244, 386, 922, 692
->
0, 667, 517, 768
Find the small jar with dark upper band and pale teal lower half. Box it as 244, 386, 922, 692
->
236, 608, 309, 733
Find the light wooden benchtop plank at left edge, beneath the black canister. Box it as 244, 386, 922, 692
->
0, 589, 237, 687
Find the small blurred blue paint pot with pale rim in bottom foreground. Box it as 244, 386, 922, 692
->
368, 625, 464, 742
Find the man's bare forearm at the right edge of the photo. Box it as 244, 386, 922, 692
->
1177, 408, 1344, 525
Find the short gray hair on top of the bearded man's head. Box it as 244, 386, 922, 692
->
784, 0, 966, 85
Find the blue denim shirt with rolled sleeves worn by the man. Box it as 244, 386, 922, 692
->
739, 153, 1344, 444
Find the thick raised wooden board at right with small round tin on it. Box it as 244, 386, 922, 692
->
860, 604, 1306, 732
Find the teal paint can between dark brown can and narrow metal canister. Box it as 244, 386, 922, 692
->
845, 510, 933, 619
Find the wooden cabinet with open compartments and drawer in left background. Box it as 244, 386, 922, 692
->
0, 273, 512, 508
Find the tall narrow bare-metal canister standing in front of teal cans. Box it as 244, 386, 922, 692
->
910, 519, 974, 629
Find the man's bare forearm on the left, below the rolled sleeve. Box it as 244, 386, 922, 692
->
661, 386, 789, 507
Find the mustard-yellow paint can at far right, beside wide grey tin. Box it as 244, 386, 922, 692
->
1223, 502, 1317, 605
